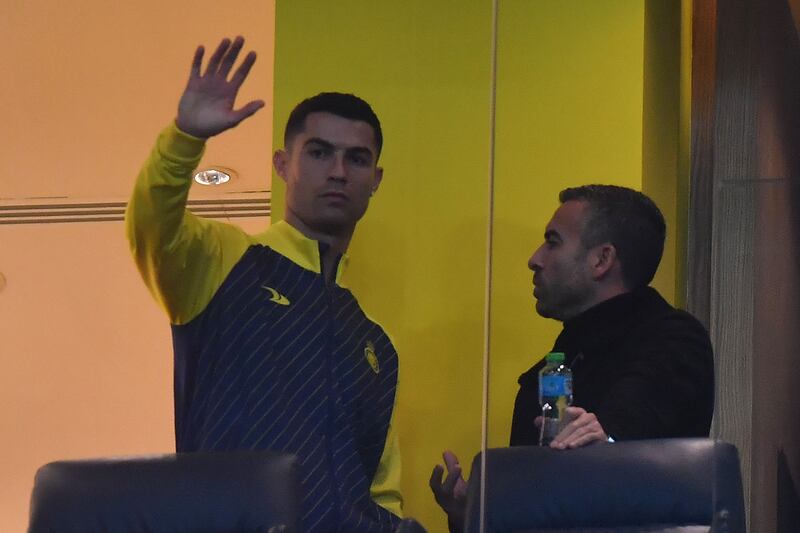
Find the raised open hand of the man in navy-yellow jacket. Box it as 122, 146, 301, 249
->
175, 37, 264, 139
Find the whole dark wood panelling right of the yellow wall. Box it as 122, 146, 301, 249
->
687, 0, 800, 533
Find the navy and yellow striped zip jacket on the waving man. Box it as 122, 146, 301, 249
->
126, 125, 402, 531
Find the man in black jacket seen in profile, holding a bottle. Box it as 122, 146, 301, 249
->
431, 185, 714, 529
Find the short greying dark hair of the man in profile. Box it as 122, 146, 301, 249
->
558, 185, 667, 289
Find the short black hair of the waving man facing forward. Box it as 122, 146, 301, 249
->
283, 92, 383, 156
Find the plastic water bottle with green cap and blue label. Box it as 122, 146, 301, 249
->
539, 352, 572, 446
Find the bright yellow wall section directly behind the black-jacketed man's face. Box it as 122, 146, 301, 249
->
489, 0, 644, 446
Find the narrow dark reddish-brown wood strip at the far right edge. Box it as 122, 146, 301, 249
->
752, 0, 800, 533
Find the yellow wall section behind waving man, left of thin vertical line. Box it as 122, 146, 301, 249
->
273, 0, 491, 532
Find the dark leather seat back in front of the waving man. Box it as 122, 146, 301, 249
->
29, 451, 300, 533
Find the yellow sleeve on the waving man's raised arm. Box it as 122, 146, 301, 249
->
125, 124, 249, 324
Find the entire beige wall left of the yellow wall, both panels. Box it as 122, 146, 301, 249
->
0, 0, 274, 531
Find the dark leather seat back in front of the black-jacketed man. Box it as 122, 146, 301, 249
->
466, 439, 746, 533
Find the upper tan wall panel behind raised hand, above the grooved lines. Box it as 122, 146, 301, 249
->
0, 0, 274, 202
